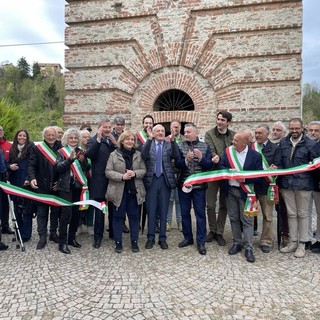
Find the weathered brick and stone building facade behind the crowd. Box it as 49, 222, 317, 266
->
64, 0, 302, 135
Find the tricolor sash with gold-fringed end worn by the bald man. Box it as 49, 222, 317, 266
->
226, 146, 259, 217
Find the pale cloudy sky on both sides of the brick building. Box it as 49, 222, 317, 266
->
0, 0, 320, 87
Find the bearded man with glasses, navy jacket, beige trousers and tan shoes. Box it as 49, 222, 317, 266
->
279, 118, 319, 258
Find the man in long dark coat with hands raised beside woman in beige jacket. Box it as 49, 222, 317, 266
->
86, 118, 117, 249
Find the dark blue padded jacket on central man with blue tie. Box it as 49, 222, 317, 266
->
141, 139, 179, 189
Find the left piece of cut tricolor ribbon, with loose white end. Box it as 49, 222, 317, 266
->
0, 182, 107, 213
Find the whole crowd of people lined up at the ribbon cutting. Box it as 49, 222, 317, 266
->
0, 115, 320, 262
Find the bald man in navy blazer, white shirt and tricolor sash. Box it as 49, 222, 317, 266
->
220, 131, 262, 262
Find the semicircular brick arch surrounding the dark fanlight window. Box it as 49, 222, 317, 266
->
130, 67, 216, 129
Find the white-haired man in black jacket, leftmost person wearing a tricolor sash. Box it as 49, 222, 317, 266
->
28, 127, 61, 250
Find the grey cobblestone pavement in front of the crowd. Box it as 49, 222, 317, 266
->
0, 212, 320, 320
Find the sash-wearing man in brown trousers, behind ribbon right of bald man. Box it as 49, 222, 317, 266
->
252, 124, 281, 253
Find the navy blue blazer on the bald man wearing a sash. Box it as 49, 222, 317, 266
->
219, 147, 263, 200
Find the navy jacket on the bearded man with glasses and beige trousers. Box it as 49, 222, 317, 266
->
278, 134, 319, 191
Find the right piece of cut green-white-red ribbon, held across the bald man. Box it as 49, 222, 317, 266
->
183, 157, 320, 188
